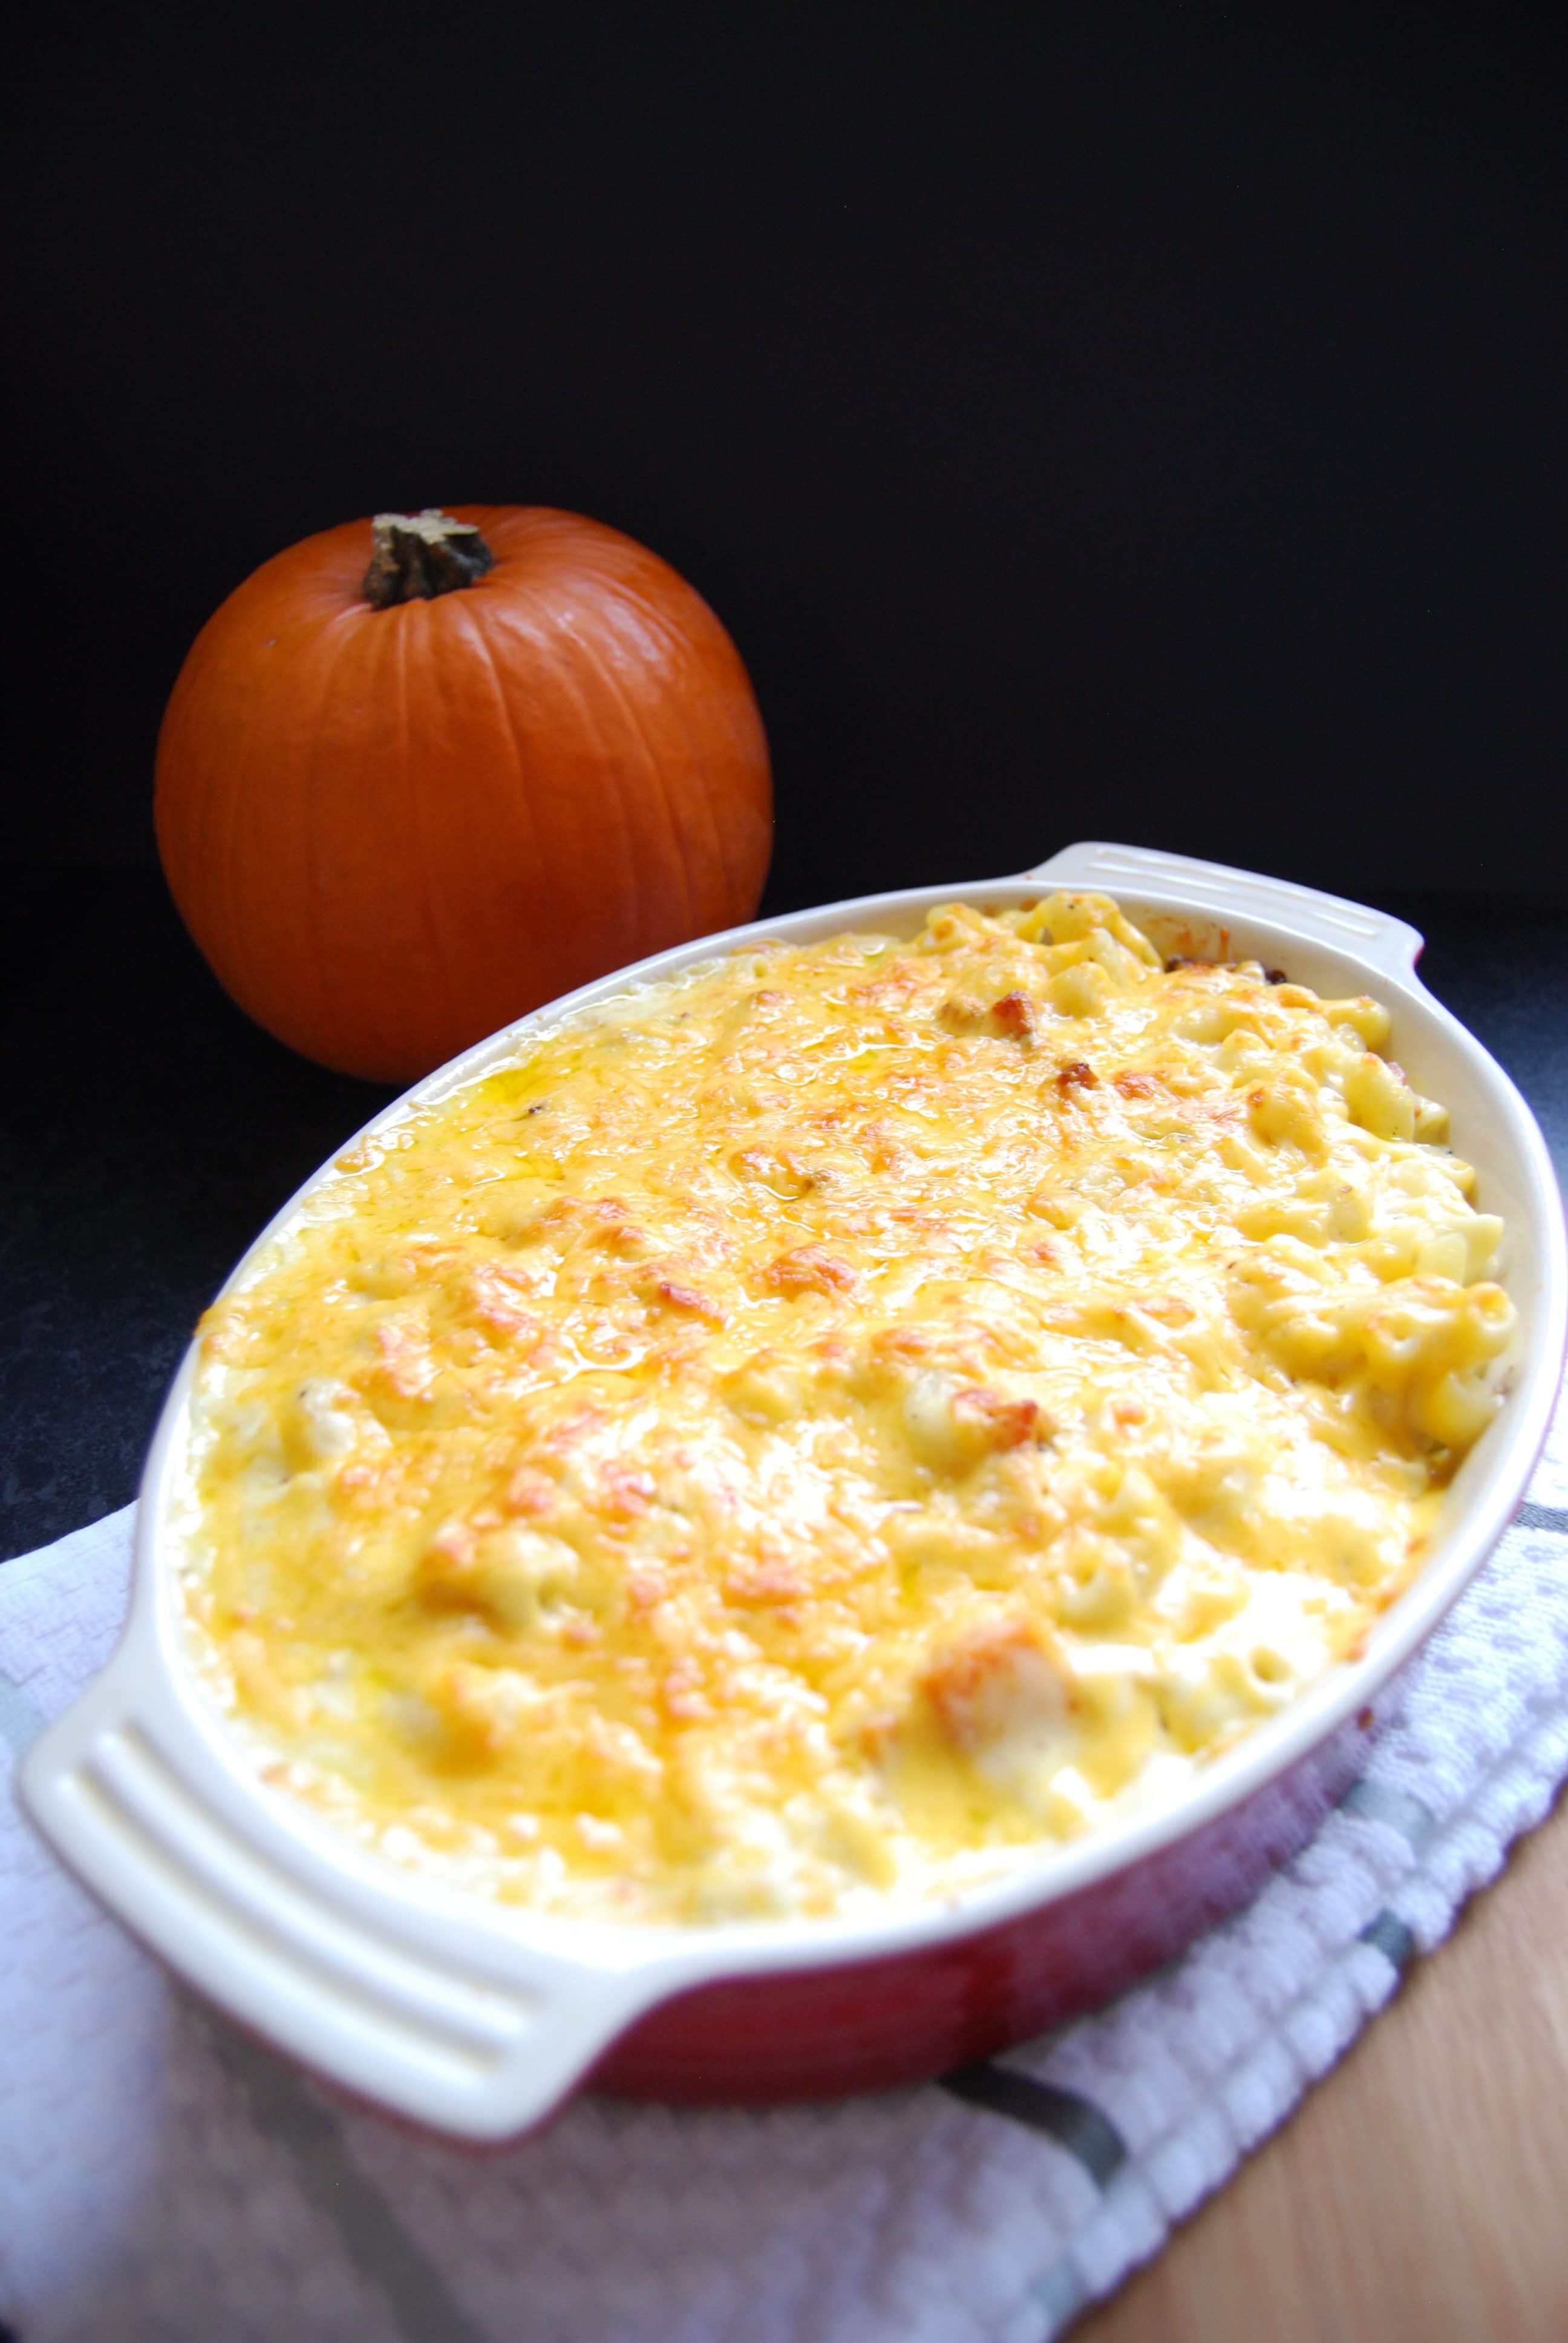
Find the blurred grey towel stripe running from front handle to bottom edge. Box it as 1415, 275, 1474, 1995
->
199, 2010, 483, 2343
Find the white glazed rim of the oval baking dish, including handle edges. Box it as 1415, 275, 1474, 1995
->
24, 844, 1568, 2137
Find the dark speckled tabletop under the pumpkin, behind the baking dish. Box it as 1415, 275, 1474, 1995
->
0, 870, 1568, 1558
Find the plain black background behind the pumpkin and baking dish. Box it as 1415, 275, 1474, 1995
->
0, 0, 1568, 906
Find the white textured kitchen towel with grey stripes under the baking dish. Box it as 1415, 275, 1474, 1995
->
0, 1368, 1568, 2343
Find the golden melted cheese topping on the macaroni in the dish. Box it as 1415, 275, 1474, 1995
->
188, 895, 1512, 1921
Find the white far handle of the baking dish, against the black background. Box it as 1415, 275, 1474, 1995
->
1022, 839, 1425, 977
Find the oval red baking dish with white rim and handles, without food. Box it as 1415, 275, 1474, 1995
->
24, 844, 1568, 2139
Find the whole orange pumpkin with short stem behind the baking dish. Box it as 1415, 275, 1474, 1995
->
155, 503, 771, 1083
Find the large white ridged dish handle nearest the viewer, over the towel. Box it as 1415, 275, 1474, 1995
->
21, 1631, 668, 2141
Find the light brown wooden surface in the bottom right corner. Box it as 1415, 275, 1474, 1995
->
1073, 1797, 1568, 2343
